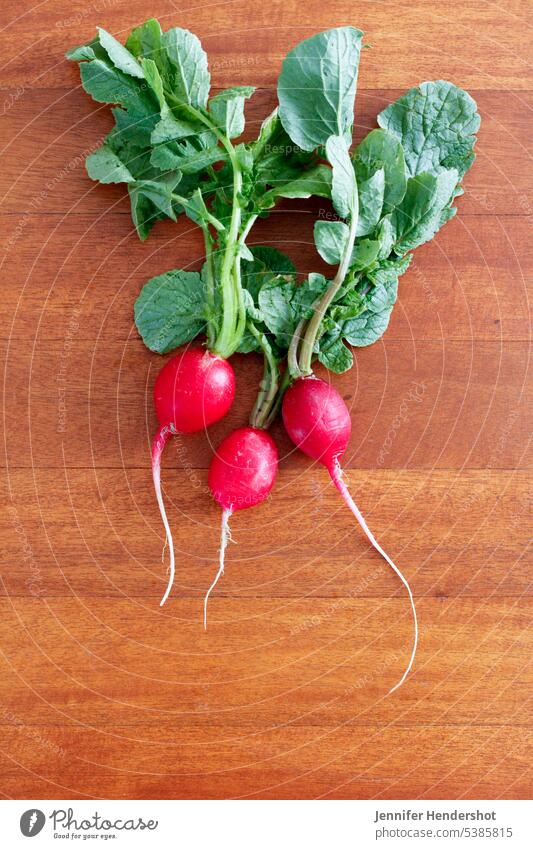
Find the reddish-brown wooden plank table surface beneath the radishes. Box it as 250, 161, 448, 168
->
0, 0, 533, 799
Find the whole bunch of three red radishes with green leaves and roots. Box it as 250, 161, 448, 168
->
67, 20, 479, 689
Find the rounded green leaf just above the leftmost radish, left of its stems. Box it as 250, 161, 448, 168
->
134, 270, 205, 354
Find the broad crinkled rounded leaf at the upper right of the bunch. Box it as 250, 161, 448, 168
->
378, 80, 480, 179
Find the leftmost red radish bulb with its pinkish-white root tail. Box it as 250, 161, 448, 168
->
152, 348, 235, 605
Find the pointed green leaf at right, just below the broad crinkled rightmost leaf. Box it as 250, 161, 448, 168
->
391, 169, 457, 256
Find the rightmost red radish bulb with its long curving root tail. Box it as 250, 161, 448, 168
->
282, 375, 418, 693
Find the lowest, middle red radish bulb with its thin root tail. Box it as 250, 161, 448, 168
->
204, 427, 278, 628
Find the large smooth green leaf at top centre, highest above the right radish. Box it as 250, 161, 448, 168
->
278, 27, 363, 150
